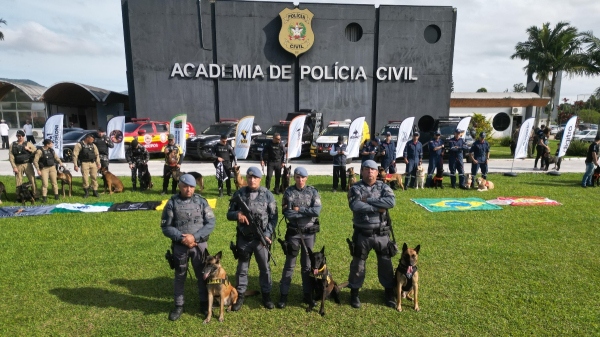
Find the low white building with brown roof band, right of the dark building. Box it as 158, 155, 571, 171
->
450, 92, 550, 138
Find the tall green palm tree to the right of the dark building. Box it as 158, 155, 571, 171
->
510, 21, 587, 125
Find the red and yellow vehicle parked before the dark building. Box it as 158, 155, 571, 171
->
124, 118, 196, 153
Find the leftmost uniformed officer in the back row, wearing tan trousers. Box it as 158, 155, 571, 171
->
8, 130, 37, 198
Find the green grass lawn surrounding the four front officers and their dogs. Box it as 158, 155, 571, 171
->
0, 174, 600, 336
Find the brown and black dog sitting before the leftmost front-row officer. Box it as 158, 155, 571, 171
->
202, 250, 238, 324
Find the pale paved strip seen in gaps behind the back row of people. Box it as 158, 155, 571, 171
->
0, 149, 585, 177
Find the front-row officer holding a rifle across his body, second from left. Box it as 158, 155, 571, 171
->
227, 166, 277, 311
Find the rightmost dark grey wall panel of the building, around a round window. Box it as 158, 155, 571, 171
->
376, 6, 454, 130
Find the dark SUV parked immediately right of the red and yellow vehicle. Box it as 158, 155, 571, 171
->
186, 119, 262, 160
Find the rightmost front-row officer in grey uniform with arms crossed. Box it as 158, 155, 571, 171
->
348, 160, 396, 308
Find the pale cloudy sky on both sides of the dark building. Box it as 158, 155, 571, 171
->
0, 0, 600, 99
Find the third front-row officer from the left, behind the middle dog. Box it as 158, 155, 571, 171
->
277, 167, 321, 309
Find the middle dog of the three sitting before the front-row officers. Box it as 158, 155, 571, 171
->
306, 246, 346, 316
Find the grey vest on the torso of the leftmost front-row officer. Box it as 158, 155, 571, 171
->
171, 194, 204, 234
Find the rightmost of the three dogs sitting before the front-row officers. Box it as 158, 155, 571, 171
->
394, 243, 421, 311
